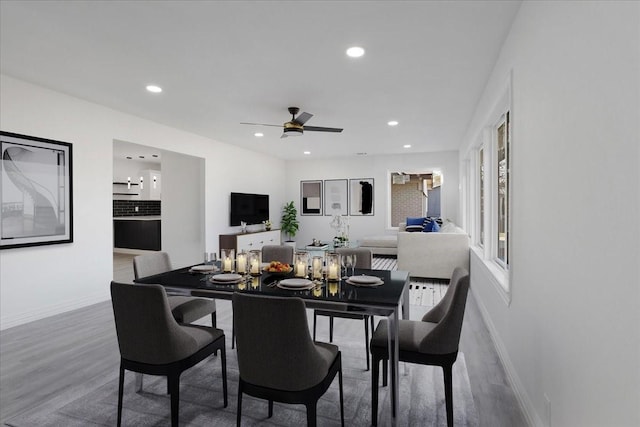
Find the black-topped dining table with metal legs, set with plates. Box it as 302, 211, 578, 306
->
134, 263, 409, 425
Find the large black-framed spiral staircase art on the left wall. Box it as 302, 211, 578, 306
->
0, 132, 73, 249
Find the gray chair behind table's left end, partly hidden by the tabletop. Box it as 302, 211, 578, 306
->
133, 252, 216, 328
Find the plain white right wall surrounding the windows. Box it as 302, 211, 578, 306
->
461, 1, 640, 427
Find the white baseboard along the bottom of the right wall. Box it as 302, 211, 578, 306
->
470, 288, 544, 427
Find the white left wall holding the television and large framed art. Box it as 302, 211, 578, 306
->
0, 75, 285, 329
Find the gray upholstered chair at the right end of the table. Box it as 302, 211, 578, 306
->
371, 267, 469, 427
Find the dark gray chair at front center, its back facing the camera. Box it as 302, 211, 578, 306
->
233, 293, 344, 426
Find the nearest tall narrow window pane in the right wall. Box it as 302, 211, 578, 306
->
496, 112, 511, 268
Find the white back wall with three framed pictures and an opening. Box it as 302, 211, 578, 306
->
286, 151, 459, 246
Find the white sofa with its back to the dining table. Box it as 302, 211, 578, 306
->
398, 224, 469, 279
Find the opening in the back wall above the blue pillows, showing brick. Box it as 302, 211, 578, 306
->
389, 171, 442, 228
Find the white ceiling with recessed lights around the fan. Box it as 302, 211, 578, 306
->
0, 0, 520, 159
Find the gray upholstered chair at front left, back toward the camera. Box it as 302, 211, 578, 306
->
111, 282, 227, 426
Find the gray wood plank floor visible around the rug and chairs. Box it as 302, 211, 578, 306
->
0, 254, 527, 427
